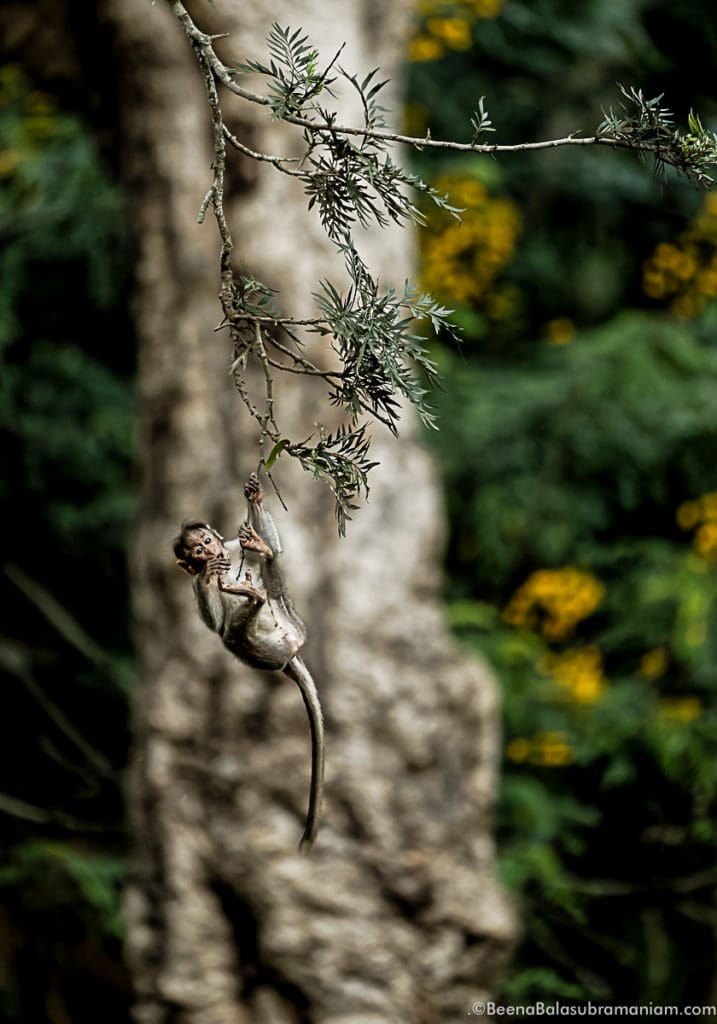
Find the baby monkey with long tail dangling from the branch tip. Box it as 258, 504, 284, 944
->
174, 473, 324, 852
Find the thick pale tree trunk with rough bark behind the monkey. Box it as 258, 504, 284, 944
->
2, 0, 516, 1024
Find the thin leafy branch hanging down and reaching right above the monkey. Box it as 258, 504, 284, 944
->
169, 0, 717, 534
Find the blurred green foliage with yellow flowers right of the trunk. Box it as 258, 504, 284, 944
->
407, 0, 717, 1005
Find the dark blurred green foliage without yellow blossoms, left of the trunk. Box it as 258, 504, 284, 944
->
0, 65, 134, 1021
